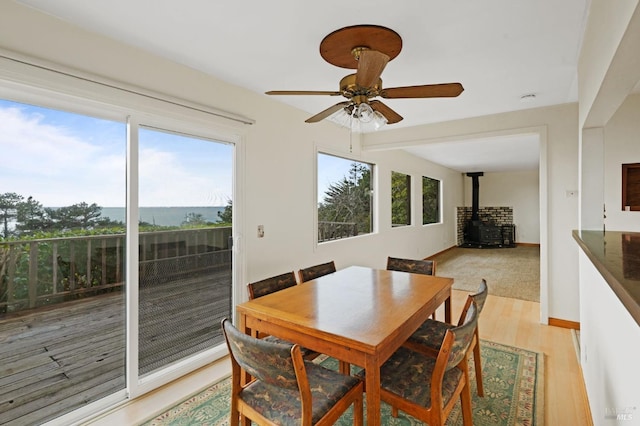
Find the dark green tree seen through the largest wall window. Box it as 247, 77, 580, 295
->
318, 162, 372, 233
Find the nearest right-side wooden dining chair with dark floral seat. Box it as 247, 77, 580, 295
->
358, 302, 478, 426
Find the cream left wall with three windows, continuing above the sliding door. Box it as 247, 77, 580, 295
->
0, 2, 462, 286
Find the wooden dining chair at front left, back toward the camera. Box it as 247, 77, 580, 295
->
222, 319, 363, 426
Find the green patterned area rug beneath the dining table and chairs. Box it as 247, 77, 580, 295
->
144, 340, 544, 426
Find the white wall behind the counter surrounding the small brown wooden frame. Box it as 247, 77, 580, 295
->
603, 95, 640, 232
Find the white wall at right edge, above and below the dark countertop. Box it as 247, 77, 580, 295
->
575, 0, 640, 425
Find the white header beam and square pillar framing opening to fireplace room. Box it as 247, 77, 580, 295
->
363, 104, 579, 321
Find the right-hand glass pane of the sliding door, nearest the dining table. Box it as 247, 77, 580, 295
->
138, 128, 233, 376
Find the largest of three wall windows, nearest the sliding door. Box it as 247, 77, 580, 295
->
317, 153, 373, 242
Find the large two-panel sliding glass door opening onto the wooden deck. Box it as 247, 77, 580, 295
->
0, 95, 236, 424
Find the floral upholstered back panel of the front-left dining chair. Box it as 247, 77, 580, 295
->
222, 319, 298, 389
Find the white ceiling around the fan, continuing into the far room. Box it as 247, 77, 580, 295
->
18, 0, 590, 171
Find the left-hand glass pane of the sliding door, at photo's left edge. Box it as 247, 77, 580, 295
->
0, 100, 126, 424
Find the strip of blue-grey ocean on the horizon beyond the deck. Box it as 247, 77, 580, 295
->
102, 206, 224, 226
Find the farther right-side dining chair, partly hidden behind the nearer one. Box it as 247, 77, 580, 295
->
403, 280, 489, 396
